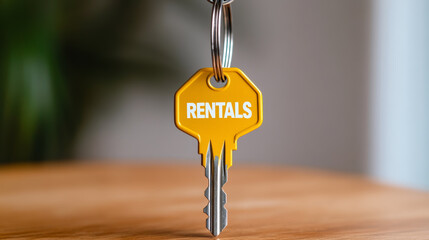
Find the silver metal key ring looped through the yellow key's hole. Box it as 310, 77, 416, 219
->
208, 0, 234, 82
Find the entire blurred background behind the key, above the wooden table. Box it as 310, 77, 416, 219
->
0, 0, 429, 189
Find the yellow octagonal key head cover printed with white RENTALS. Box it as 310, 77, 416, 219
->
175, 68, 262, 168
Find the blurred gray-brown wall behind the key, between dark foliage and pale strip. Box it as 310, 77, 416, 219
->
75, 0, 370, 171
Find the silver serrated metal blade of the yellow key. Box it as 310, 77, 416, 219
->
204, 144, 228, 236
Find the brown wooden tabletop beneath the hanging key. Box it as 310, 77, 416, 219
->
0, 163, 429, 240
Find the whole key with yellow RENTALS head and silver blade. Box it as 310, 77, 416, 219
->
175, 68, 263, 236
